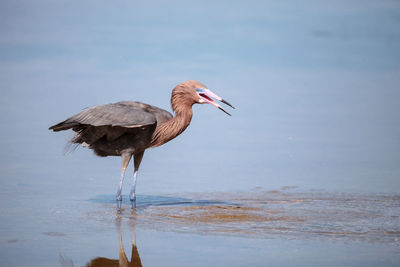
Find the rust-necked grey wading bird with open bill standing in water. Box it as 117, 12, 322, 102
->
49, 80, 234, 208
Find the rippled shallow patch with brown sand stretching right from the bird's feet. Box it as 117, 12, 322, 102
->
88, 190, 400, 246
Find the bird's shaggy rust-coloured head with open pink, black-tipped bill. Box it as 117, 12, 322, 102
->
171, 81, 234, 116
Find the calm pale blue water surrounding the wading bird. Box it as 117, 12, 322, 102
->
0, 0, 400, 266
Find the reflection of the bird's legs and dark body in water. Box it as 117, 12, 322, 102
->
86, 215, 142, 267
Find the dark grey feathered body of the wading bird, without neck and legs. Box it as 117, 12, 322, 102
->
49, 101, 172, 157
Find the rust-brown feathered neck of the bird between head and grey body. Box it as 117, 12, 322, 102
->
150, 105, 193, 147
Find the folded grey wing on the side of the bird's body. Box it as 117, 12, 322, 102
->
49, 102, 157, 131
